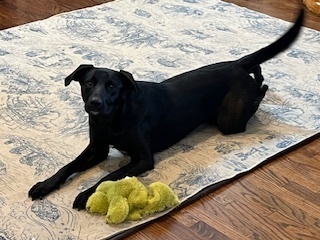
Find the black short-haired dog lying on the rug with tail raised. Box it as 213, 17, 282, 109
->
29, 10, 304, 210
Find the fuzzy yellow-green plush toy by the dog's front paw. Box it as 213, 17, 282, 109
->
86, 177, 179, 224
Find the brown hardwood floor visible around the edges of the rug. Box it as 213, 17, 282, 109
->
0, 0, 320, 240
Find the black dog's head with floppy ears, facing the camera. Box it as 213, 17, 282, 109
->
65, 65, 138, 115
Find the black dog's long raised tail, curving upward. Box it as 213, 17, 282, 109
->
237, 9, 304, 71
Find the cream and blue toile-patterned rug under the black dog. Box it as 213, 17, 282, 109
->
0, 0, 320, 239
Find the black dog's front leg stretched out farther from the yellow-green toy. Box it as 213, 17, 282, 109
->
29, 142, 109, 200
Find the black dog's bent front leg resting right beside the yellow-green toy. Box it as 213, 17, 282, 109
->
73, 129, 154, 210
